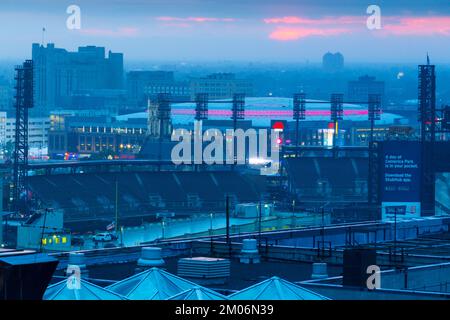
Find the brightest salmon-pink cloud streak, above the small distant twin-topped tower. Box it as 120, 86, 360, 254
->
269, 27, 350, 41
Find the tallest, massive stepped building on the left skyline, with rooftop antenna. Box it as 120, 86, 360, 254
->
32, 43, 123, 114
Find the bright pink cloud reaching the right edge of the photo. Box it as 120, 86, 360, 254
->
382, 16, 450, 36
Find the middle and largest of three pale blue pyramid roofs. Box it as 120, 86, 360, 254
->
107, 268, 198, 300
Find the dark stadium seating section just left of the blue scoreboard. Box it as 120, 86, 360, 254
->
286, 157, 368, 202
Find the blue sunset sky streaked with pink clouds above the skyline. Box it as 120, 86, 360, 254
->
0, 0, 450, 63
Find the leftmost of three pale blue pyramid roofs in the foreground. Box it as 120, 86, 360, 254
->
44, 279, 126, 300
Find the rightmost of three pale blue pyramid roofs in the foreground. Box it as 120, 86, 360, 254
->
228, 277, 329, 300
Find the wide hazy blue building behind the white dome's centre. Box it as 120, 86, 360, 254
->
190, 73, 253, 100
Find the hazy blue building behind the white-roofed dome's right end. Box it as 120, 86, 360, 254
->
348, 75, 384, 102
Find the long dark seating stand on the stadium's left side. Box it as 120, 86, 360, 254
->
29, 171, 265, 226
